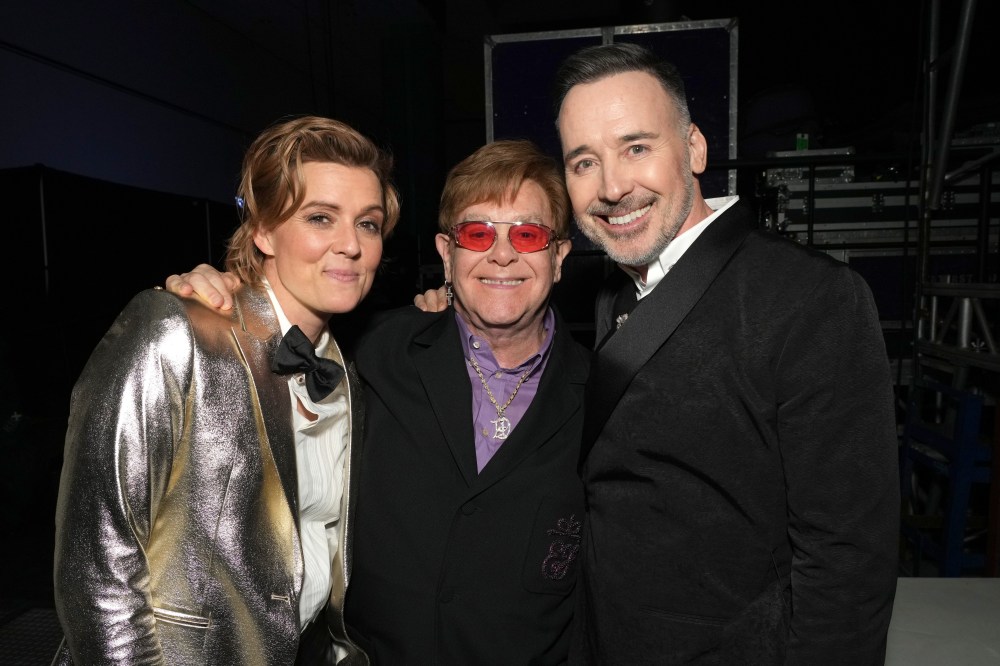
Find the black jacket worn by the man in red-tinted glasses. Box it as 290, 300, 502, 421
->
345, 307, 589, 666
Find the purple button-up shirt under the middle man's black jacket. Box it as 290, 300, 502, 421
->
455, 308, 556, 472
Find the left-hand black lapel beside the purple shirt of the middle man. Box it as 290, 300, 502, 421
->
413, 309, 478, 485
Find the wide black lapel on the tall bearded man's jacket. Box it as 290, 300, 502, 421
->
580, 204, 753, 461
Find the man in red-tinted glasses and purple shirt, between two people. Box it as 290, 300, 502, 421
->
167, 141, 589, 666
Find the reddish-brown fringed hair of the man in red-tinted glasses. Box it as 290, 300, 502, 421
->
438, 139, 570, 238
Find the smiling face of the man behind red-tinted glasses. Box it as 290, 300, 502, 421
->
435, 180, 570, 341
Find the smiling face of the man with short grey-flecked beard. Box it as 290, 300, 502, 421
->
558, 71, 711, 270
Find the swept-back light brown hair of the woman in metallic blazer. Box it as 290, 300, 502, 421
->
225, 116, 399, 284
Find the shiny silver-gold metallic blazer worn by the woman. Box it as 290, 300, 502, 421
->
54, 286, 367, 665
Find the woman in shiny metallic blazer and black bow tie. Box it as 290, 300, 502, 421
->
55, 117, 399, 665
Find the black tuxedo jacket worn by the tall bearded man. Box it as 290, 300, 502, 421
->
576, 205, 899, 666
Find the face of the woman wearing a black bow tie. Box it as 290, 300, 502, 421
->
254, 162, 385, 340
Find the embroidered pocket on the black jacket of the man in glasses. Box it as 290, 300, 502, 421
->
522, 497, 584, 595
